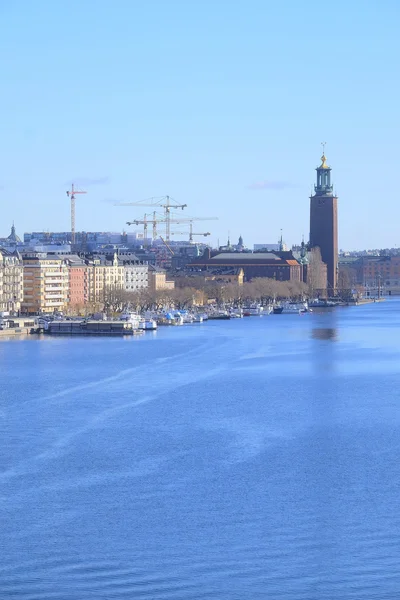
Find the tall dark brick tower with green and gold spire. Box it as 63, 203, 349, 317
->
310, 151, 338, 295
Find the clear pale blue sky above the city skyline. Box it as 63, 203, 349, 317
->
0, 0, 400, 248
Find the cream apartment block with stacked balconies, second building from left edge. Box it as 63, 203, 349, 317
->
21, 252, 69, 314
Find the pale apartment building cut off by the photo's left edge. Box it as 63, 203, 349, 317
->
0, 248, 24, 313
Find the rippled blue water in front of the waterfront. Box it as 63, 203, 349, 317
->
0, 301, 400, 600
